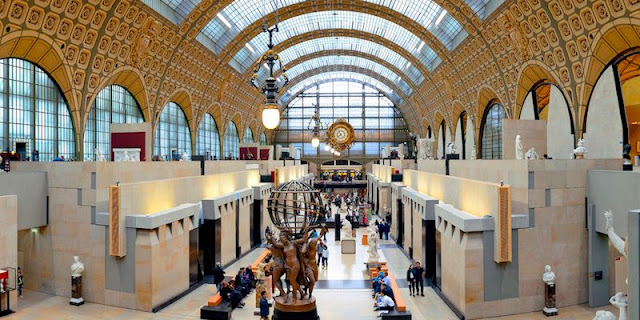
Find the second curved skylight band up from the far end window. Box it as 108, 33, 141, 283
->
262, 56, 413, 96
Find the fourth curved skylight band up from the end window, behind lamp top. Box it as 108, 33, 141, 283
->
229, 11, 437, 73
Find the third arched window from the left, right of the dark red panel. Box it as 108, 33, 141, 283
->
153, 102, 191, 160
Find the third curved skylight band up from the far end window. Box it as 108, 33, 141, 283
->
258, 37, 424, 85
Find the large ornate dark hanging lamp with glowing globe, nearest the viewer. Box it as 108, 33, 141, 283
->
250, 18, 289, 130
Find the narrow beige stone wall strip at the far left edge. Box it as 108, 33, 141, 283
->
0, 196, 22, 310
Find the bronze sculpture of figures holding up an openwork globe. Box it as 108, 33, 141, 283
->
267, 181, 326, 320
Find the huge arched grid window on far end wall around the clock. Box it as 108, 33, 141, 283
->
273, 78, 409, 159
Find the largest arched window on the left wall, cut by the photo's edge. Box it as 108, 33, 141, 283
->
0, 58, 76, 161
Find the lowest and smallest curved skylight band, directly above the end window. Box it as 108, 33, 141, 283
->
280, 71, 403, 105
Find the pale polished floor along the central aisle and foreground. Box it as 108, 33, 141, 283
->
6, 228, 617, 320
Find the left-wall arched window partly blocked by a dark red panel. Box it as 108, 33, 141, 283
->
84, 85, 144, 160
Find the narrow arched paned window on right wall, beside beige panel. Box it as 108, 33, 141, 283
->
481, 102, 507, 159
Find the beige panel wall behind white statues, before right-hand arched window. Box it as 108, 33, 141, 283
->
502, 119, 548, 160
